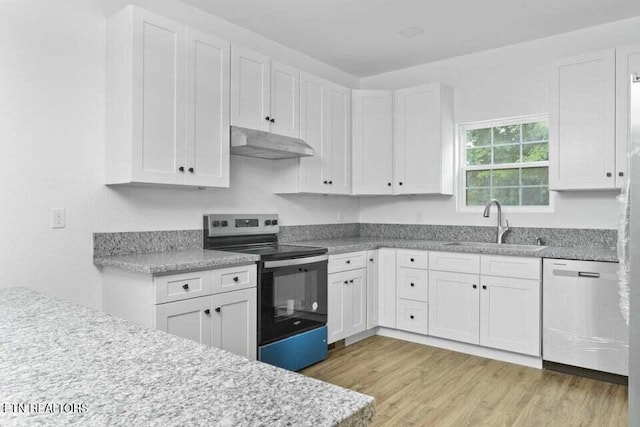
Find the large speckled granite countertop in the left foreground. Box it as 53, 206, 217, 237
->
0, 288, 374, 426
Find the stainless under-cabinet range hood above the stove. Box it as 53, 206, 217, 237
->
231, 126, 314, 160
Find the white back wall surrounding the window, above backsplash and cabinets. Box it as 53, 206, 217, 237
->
360, 18, 640, 228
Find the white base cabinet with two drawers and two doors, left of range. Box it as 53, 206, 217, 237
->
103, 264, 258, 360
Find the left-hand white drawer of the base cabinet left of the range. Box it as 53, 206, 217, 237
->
154, 270, 211, 304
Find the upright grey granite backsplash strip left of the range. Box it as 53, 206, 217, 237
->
93, 230, 202, 258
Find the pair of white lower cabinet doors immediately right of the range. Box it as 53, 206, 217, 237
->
327, 269, 367, 344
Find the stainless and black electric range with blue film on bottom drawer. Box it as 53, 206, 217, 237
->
203, 214, 328, 371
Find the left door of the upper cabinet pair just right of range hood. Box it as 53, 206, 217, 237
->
299, 73, 332, 193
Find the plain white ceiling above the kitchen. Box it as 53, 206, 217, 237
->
182, 0, 640, 77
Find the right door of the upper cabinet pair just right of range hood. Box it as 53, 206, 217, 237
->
324, 84, 351, 194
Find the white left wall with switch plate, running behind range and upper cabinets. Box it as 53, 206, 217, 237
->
0, 0, 358, 308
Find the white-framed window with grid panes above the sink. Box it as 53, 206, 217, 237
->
460, 116, 549, 207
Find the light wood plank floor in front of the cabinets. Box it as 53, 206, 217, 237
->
302, 336, 627, 427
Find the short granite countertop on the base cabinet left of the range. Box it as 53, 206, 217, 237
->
93, 249, 260, 274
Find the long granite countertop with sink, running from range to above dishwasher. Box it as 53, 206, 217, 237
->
287, 237, 618, 262
